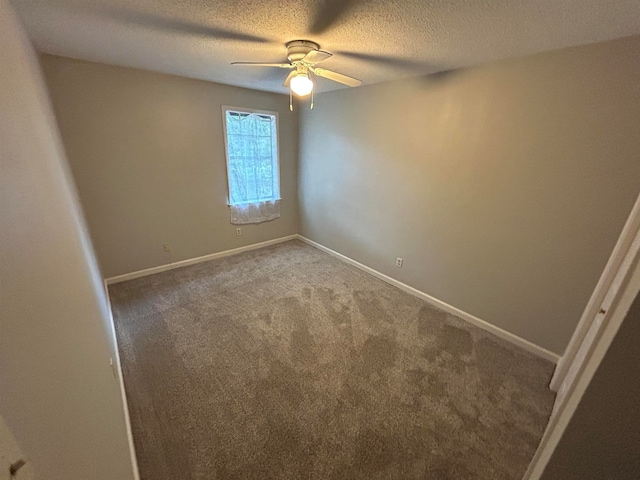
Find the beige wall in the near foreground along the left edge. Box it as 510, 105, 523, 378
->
0, 0, 134, 480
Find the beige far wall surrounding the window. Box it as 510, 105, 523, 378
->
41, 55, 298, 277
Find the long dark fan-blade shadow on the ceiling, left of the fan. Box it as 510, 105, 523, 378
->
91, 7, 271, 43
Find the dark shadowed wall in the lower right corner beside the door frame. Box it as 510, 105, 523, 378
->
541, 284, 640, 480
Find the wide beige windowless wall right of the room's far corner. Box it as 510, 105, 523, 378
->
299, 37, 640, 353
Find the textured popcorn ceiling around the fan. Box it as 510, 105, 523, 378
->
13, 0, 640, 93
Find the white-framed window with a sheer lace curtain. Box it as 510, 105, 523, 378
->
222, 107, 280, 224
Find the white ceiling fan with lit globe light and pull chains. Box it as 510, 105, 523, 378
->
231, 40, 362, 110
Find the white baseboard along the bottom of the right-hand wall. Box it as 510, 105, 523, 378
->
295, 235, 560, 364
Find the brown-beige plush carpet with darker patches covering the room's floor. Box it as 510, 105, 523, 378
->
110, 241, 553, 480
